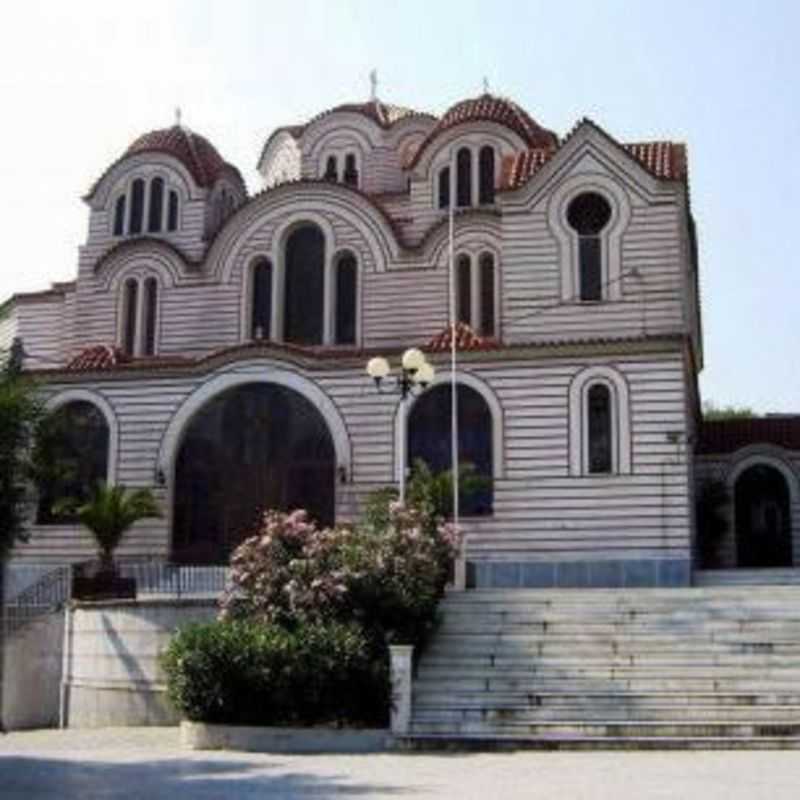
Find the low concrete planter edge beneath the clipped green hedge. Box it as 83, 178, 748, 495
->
181, 721, 392, 753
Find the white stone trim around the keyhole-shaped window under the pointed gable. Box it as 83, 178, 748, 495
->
547, 173, 631, 303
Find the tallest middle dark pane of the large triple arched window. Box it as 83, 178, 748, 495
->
284, 225, 325, 344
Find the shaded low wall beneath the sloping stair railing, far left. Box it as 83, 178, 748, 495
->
0, 611, 64, 731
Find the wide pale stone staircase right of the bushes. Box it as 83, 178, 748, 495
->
403, 586, 800, 749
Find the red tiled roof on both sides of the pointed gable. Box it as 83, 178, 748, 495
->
500, 142, 686, 190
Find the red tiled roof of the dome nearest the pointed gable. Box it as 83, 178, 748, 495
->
406, 94, 558, 169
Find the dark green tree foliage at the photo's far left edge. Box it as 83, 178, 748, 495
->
0, 369, 43, 560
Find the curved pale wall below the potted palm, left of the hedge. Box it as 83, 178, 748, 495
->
62, 598, 218, 728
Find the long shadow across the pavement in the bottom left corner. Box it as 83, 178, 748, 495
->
0, 756, 405, 800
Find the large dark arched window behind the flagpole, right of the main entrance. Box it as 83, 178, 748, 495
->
407, 383, 494, 515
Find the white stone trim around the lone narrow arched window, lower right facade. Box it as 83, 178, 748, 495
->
569, 366, 631, 477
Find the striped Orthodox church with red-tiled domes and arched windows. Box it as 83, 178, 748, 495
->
0, 93, 800, 587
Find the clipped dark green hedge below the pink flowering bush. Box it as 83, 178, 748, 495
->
162, 620, 390, 726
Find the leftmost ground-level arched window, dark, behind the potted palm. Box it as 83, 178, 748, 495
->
37, 400, 110, 524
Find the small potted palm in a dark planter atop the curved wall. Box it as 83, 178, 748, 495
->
72, 483, 161, 600
